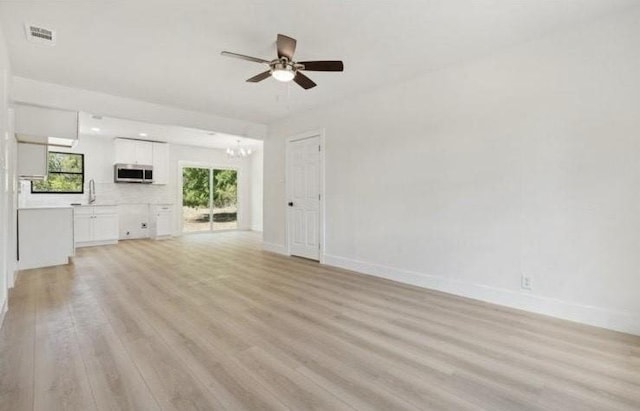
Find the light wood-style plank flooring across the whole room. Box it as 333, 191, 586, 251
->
0, 232, 640, 411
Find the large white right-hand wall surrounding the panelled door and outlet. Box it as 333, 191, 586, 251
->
264, 11, 640, 334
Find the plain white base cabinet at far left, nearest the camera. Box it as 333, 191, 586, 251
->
18, 207, 75, 270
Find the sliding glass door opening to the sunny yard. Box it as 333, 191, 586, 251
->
182, 167, 238, 233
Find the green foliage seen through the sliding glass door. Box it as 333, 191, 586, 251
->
182, 167, 238, 208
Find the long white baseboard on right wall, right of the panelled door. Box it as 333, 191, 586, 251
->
324, 254, 640, 335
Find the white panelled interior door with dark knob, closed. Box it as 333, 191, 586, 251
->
287, 136, 320, 260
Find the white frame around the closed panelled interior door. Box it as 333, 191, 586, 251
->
282, 128, 326, 264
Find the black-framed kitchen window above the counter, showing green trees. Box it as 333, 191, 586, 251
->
31, 151, 84, 194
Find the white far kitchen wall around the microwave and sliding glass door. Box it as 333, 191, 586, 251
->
19, 135, 262, 238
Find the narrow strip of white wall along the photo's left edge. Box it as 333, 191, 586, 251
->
0, 21, 15, 325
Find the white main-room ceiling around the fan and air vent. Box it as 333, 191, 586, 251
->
0, 0, 638, 123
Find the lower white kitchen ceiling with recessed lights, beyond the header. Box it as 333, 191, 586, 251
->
79, 112, 262, 151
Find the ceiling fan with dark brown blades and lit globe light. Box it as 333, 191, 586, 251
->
220, 34, 344, 90
